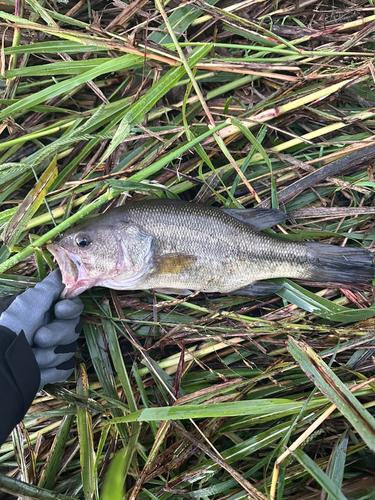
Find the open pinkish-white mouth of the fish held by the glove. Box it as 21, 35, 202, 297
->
47, 244, 98, 299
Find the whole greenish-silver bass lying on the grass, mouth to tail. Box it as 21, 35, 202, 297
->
47, 199, 375, 298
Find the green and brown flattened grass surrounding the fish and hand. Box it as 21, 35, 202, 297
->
0, 0, 375, 500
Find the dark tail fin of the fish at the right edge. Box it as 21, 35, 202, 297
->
306, 243, 375, 283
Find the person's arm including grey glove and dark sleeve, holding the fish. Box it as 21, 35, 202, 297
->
0, 271, 83, 445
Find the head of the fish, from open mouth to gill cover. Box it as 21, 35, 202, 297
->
47, 219, 153, 299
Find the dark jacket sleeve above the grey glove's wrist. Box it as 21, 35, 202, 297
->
0, 301, 40, 445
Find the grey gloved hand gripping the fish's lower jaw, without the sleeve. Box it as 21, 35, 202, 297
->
0, 269, 83, 389
